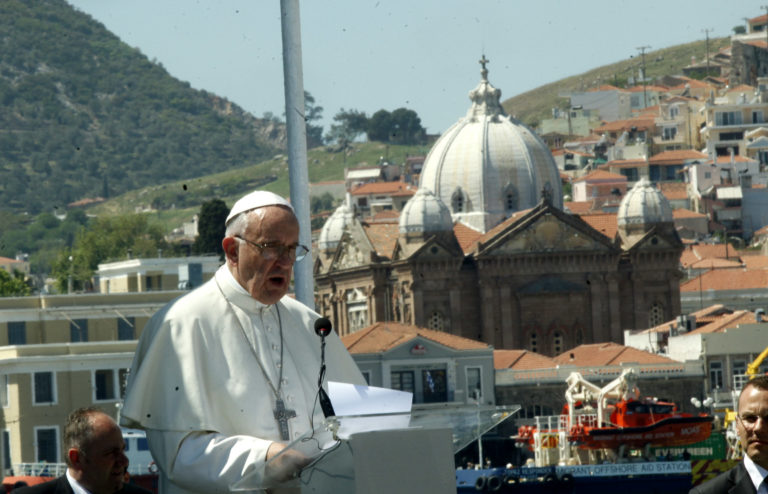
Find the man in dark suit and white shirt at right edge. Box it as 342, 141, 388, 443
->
689, 375, 768, 494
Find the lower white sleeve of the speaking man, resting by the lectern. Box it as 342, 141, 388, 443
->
147, 430, 272, 493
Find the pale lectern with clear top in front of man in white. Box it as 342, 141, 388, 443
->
260, 406, 519, 494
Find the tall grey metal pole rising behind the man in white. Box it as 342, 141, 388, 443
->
280, 0, 315, 309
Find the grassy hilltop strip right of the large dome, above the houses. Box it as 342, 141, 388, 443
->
502, 38, 731, 127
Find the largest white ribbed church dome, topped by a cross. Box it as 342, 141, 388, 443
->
420, 57, 563, 232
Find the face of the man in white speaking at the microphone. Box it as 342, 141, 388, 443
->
224, 206, 299, 305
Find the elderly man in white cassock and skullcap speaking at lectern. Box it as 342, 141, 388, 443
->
121, 191, 365, 494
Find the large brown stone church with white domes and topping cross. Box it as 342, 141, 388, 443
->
314, 59, 682, 355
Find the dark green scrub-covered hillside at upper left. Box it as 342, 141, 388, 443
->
0, 0, 284, 214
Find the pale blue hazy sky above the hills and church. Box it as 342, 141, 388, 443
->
68, 0, 765, 133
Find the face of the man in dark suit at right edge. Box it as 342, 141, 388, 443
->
736, 385, 768, 468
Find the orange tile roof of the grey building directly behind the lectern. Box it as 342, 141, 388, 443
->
341, 322, 491, 354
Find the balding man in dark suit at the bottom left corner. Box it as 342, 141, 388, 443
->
14, 408, 151, 494
